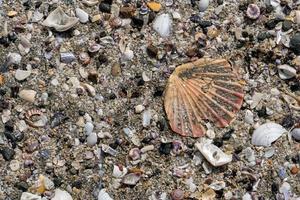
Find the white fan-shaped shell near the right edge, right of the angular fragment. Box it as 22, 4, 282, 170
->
252, 122, 286, 147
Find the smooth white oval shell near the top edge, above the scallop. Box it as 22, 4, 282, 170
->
153, 14, 172, 37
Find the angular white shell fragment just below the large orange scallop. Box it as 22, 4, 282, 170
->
195, 140, 232, 167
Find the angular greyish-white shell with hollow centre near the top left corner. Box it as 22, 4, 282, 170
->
43, 7, 79, 32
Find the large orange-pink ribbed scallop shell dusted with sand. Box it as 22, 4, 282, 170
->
164, 58, 244, 137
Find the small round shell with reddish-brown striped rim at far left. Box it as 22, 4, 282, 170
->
25, 109, 48, 128
